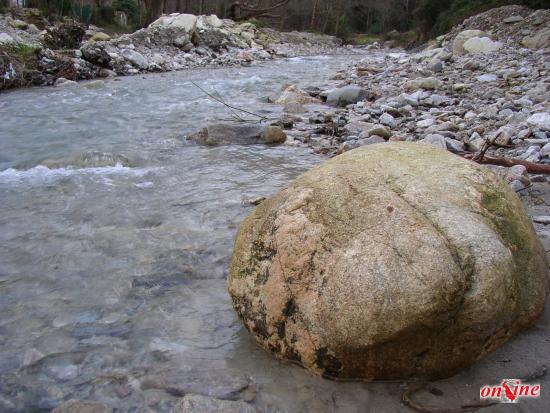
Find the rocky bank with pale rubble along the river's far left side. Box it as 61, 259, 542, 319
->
0, 9, 341, 90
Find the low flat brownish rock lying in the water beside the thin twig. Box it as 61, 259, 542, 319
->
188, 123, 286, 146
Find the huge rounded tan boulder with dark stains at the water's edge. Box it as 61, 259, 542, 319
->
228, 142, 548, 380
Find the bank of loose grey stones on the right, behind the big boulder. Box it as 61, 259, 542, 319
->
245, 6, 550, 191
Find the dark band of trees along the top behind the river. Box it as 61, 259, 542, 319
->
22, 0, 550, 37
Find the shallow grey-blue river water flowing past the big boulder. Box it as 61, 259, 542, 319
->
0, 55, 548, 413
